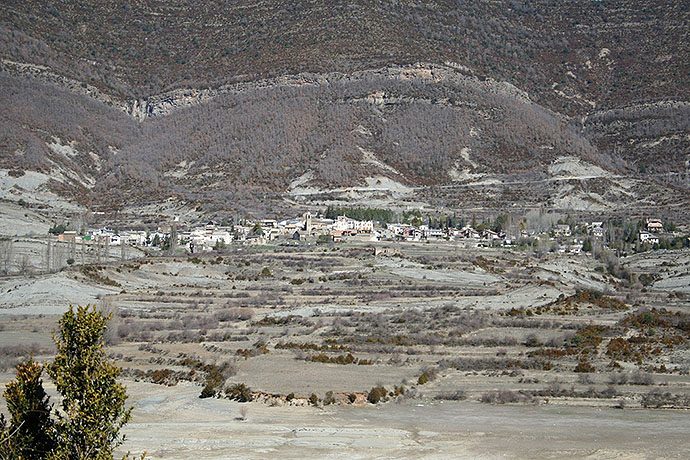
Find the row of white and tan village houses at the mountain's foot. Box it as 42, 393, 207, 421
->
51, 212, 689, 254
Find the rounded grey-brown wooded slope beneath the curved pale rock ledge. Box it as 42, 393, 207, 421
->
1, 66, 596, 207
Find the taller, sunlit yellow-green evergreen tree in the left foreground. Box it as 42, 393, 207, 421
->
47, 305, 131, 460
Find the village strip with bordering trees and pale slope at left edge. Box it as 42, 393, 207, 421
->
0, 208, 690, 275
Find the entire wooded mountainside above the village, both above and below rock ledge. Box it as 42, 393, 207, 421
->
0, 0, 690, 212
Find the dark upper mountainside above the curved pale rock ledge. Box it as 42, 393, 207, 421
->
0, 0, 690, 112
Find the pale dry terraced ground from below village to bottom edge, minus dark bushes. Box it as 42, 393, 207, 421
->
0, 240, 690, 459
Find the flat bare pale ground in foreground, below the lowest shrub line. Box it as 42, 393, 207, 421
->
115, 383, 690, 459
